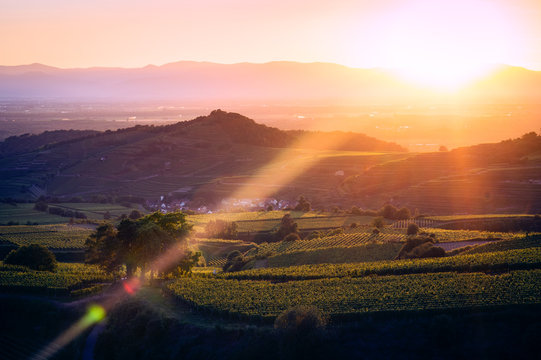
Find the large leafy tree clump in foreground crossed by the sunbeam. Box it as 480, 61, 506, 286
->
85, 212, 192, 278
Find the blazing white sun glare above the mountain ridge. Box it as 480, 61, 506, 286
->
364, 0, 519, 91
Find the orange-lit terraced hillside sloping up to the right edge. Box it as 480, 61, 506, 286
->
342, 133, 541, 214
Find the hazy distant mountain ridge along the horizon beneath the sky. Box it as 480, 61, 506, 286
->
0, 61, 541, 103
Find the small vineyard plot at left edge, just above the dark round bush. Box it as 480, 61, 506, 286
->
0, 224, 92, 249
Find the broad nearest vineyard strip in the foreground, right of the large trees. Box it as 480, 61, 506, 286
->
167, 270, 541, 320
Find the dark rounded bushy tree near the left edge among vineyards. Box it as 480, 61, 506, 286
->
4, 244, 56, 271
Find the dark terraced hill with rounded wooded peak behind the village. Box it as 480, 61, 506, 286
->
0, 110, 404, 200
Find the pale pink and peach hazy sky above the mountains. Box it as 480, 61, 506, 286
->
0, 0, 541, 70
